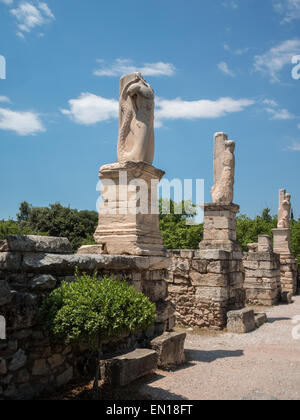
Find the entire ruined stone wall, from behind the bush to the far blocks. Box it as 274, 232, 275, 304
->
0, 238, 300, 399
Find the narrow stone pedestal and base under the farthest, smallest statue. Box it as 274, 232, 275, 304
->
272, 228, 298, 295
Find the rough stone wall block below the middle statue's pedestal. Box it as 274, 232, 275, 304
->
167, 249, 245, 330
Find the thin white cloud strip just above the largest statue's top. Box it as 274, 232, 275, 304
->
94, 59, 175, 77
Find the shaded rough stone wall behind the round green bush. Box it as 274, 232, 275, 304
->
0, 236, 175, 400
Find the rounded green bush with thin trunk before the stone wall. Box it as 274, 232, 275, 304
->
40, 272, 156, 390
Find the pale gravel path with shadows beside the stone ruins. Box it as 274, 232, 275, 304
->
142, 296, 300, 400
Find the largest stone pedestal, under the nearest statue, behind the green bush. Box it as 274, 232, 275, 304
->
84, 162, 165, 256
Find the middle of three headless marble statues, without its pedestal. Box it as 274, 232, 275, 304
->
211, 133, 235, 205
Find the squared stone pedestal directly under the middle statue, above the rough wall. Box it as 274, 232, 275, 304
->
199, 203, 241, 252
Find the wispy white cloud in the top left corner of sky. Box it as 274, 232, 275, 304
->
10, 1, 55, 38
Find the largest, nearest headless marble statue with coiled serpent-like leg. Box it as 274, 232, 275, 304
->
118, 73, 154, 165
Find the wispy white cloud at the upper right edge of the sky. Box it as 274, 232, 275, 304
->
254, 39, 300, 83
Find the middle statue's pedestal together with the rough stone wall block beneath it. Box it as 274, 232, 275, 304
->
168, 203, 245, 329
